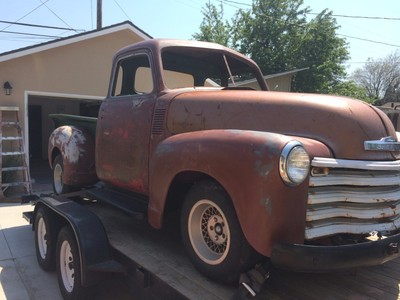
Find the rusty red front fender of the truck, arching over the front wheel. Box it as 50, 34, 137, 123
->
149, 130, 322, 256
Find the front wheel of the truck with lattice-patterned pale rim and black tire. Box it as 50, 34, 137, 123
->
181, 181, 256, 283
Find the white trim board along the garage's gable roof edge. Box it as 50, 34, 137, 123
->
0, 23, 150, 62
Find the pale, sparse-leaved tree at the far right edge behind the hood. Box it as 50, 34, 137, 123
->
351, 51, 400, 103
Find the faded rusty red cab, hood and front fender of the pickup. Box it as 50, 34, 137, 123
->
49, 40, 399, 256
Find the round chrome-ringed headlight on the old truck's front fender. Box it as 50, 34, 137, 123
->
279, 141, 310, 186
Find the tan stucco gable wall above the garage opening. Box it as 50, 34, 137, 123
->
0, 29, 147, 162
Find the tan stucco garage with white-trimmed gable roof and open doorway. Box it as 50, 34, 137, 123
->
0, 22, 152, 159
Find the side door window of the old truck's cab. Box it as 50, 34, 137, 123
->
112, 54, 154, 96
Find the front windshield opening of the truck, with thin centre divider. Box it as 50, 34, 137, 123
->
162, 47, 261, 90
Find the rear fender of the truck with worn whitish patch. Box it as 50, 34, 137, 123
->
48, 125, 97, 186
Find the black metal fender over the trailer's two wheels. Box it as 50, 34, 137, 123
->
32, 196, 125, 286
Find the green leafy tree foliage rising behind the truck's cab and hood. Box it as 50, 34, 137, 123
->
193, 0, 349, 93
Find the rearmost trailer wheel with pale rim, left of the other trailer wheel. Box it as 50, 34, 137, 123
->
34, 207, 57, 271
